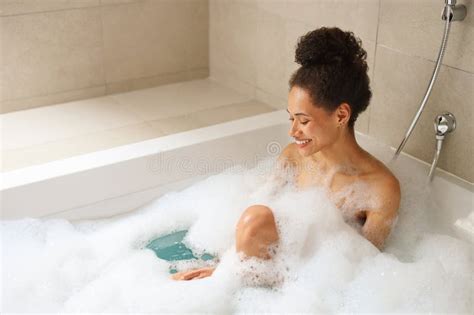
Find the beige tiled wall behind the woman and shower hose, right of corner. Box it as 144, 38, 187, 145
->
209, 0, 474, 182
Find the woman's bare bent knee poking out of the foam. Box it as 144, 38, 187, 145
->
235, 205, 279, 259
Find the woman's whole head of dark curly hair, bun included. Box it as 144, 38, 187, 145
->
289, 27, 372, 129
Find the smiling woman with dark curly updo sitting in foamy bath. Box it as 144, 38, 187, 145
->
173, 28, 400, 280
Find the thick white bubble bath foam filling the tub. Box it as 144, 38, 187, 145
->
1, 153, 473, 314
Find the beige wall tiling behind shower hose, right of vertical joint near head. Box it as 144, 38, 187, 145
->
369, 0, 474, 182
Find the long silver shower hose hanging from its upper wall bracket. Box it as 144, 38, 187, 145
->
393, 0, 467, 160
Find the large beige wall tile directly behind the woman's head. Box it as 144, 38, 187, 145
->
209, 0, 379, 133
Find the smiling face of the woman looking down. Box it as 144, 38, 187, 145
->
287, 86, 340, 156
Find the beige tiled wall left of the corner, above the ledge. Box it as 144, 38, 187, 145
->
0, 0, 209, 113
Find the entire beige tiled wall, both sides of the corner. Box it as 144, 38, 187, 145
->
0, 0, 474, 182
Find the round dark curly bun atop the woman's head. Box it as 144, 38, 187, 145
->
295, 27, 367, 67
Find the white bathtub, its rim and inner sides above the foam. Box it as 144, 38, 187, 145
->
0, 111, 473, 241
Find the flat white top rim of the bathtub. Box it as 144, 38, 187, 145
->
0, 110, 474, 193
